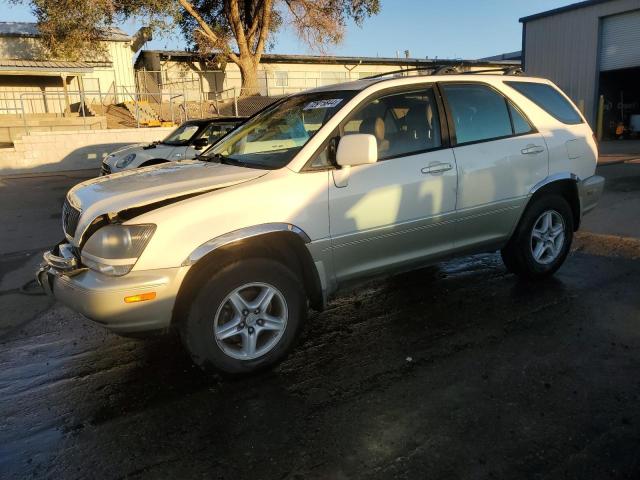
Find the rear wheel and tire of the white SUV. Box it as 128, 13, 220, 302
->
501, 194, 573, 280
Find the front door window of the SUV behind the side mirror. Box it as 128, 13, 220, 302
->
342, 88, 441, 160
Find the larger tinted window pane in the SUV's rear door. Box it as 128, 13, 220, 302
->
443, 84, 512, 145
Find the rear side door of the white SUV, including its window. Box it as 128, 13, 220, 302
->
440, 82, 549, 250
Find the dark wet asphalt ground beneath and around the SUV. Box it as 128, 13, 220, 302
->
0, 164, 640, 479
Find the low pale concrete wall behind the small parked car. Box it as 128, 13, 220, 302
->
0, 128, 173, 175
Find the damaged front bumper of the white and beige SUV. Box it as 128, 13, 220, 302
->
36, 243, 189, 334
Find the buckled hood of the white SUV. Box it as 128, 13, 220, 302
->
67, 160, 268, 244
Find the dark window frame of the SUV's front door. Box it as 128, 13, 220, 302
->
300, 81, 452, 173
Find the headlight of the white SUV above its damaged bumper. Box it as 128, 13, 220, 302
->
80, 224, 156, 277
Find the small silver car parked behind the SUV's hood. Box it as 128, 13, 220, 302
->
100, 117, 246, 175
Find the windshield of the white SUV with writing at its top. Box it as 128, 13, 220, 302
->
204, 90, 356, 169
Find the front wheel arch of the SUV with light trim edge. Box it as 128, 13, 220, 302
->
172, 224, 325, 323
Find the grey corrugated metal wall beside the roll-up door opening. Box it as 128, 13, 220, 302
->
524, 0, 640, 125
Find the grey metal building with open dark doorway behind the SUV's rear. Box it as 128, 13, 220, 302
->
520, 0, 640, 138
